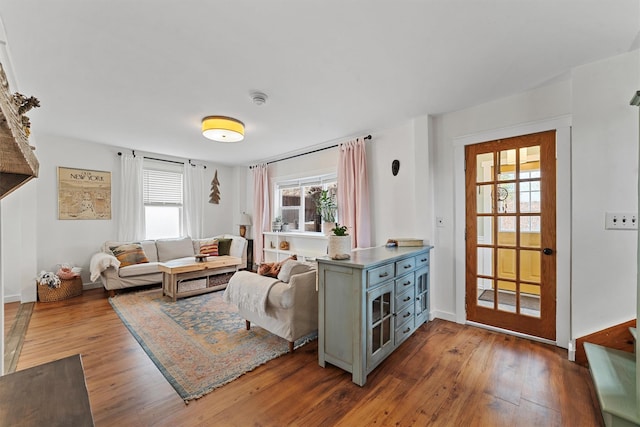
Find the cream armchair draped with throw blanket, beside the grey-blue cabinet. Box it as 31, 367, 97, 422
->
224, 261, 318, 352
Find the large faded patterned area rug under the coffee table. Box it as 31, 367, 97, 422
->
109, 289, 316, 402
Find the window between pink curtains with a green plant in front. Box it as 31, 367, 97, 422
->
275, 174, 338, 232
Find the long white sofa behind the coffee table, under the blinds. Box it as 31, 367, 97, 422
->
91, 234, 247, 296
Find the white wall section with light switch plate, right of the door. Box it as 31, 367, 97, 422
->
572, 51, 640, 337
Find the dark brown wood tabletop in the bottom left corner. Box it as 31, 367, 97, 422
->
0, 354, 94, 427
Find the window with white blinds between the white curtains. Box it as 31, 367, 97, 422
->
143, 160, 182, 239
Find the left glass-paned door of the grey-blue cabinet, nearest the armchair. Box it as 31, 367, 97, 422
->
367, 281, 394, 371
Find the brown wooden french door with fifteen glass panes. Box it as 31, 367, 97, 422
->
465, 131, 556, 340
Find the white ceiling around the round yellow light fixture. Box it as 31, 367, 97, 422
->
0, 0, 640, 165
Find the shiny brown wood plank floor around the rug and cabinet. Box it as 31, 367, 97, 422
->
10, 289, 603, 427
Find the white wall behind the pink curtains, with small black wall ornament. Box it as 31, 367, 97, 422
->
247, 118, 433, 254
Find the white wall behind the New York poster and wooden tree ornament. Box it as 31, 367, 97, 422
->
1, 135, 239, 302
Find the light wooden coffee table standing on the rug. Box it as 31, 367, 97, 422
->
158, 255, 242, 301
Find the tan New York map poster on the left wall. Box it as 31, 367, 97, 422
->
58, 166, 111, 219
